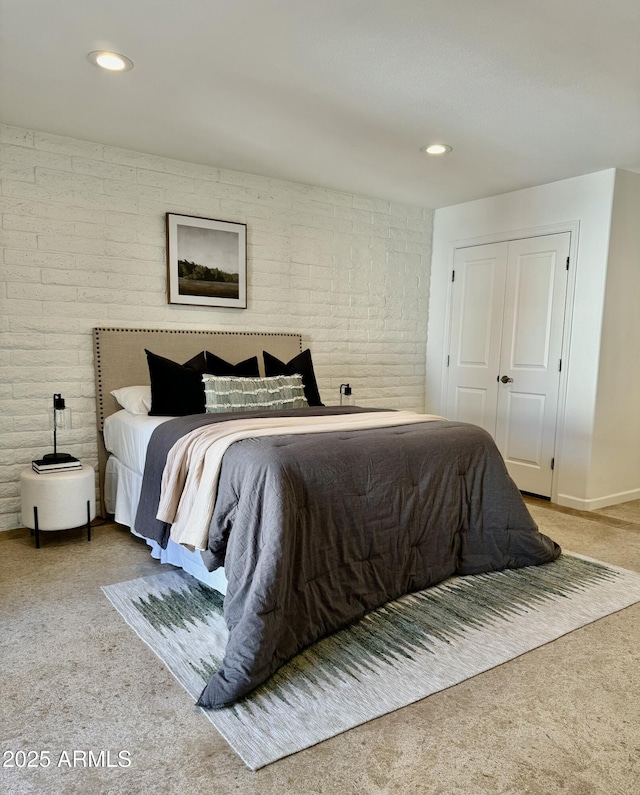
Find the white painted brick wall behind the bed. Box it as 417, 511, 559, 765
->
0, 125, 433, 529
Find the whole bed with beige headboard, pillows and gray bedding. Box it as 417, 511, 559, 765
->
95, 328, 560, 708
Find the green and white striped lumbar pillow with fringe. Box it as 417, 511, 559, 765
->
202, 375, 309, 414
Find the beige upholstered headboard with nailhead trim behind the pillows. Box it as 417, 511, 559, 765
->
93, 328, 302, 512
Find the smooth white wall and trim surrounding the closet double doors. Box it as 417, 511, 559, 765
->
426, 169, 616, 508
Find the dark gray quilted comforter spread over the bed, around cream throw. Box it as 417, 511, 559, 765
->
136, 408, 560, 708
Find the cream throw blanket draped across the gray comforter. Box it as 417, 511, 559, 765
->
156, 411, 445, 550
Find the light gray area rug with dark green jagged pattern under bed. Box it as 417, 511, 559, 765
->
103, 554, 640, 770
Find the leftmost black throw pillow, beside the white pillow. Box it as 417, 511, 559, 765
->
145, 348, 207, 417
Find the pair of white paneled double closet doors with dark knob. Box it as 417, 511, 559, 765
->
447, 232, 571, 497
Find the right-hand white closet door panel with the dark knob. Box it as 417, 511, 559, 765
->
495, 232, 570, 497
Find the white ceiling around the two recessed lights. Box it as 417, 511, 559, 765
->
0, 0, 640, 207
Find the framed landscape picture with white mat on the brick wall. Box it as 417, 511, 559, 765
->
166, 213, 247, 309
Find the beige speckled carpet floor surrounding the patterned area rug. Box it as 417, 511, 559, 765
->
0, 498, 640, 795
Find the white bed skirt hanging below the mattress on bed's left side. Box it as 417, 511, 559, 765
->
104, 456, 227, 594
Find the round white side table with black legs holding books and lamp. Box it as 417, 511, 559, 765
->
20, 464, 96, 549
